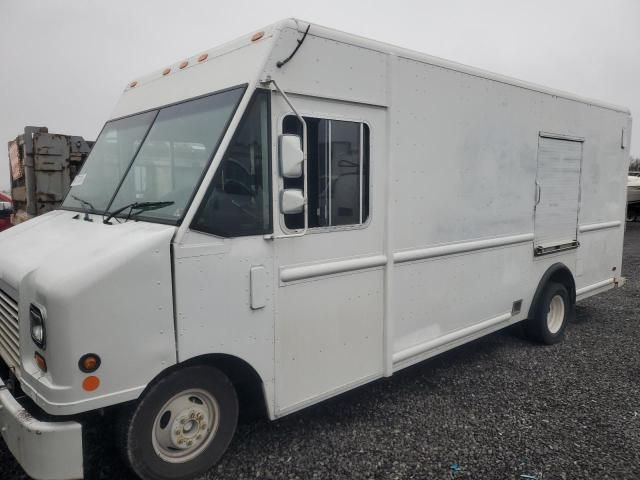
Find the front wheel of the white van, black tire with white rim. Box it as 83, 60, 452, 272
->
119, 366, 238, 480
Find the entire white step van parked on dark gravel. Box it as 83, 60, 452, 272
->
0, 19, 631, 479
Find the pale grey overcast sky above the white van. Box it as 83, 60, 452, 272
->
0, 0, 640, 189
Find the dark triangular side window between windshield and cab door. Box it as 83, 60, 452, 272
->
191, 91, 272, 237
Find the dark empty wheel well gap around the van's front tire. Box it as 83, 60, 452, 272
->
178, 353, 267, 417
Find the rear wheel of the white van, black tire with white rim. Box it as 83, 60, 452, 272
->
525, 282, 573, 345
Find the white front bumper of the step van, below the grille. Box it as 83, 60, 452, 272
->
0, 379, 84, 480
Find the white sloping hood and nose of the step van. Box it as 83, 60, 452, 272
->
0, 210, 176, 415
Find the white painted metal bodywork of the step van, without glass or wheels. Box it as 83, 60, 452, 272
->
0, 20, 631, 476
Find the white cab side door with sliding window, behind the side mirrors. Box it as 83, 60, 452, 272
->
273, 95, 386, 415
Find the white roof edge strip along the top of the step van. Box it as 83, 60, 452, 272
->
113, 18, 631, 118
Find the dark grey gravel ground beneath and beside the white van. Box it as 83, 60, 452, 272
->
0, 224, 640, 480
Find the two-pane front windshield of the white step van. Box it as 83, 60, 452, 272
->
62, 87, 244, 223
